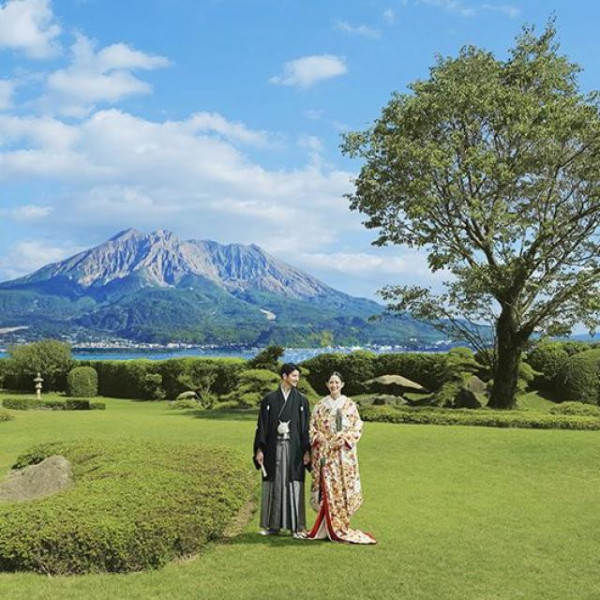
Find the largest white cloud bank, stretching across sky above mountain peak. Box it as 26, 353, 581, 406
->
0, 109, 360, 257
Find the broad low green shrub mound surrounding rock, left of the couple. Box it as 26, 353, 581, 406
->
0, 440, 254, 574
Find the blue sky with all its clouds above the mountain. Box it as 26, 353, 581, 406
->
0, 0, 600, 297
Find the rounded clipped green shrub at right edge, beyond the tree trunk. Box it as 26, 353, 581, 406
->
556, 348, 600, 404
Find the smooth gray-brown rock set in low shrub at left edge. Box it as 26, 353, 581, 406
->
0, 455, 73, 501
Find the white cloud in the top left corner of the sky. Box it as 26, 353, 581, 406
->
0, 0, 60, 59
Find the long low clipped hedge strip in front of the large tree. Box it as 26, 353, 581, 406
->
361, 406, 600, 431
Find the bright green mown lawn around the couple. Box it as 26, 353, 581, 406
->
0, 392, 600, 600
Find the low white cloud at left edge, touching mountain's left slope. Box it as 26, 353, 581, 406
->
0, 239, 83, 280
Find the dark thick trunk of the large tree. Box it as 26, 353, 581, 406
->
488, 306, 524, 409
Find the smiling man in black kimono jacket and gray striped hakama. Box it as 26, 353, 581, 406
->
253, 363, 310, 537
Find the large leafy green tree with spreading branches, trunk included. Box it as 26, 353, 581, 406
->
342, 21, 600, 408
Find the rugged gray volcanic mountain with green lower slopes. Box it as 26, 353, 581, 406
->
0, 229, 439, 345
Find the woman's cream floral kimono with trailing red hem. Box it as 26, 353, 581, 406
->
308, 396, 376, 544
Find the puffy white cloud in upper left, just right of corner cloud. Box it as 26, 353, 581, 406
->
42, 34, 169, 117
